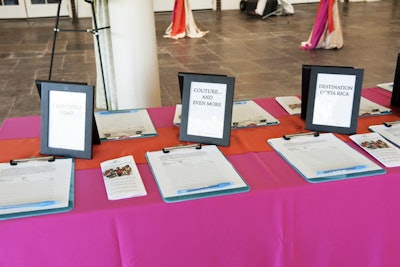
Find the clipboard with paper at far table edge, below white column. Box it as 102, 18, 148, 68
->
94, 109, 157, 140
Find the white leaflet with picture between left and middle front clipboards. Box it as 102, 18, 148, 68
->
100, 156, 147, 200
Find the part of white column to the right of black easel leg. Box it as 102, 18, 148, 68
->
108, 0, 161, 109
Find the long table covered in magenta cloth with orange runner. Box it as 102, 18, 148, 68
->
0, 88, 400, 267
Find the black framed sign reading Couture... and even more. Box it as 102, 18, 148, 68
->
179, 74, 235, 146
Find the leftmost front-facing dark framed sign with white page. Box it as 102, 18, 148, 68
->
40, 82, 94, 159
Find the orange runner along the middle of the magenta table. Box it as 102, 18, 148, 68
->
0, 114, 399, 172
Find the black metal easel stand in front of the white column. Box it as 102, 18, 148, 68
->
49, 0, 110, 110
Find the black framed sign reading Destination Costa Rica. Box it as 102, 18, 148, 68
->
306, 67, 364, 134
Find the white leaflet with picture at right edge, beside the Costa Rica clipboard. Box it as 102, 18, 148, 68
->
350, 133, 400, 167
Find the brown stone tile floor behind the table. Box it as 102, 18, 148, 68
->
0, 0, 400, 125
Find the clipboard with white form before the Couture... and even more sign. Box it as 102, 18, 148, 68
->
146, 144, 250, 203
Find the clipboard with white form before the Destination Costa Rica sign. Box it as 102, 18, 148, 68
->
268, 133, 384, 181
